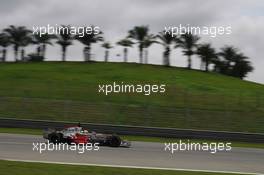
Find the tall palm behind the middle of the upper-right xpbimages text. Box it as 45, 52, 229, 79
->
175, 33, 200, 69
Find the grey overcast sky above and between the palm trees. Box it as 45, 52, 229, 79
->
0, 0, 264, 84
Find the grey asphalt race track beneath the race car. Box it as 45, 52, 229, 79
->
0, 133, 264, 174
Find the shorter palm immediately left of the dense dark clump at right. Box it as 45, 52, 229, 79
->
196, 43, 217, 72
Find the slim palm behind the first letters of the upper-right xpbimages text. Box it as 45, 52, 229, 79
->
157, 31, 176, 66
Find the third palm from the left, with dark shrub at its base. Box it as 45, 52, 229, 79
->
33, 33, 56, 58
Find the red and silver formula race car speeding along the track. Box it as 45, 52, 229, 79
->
43, 126, 131, 147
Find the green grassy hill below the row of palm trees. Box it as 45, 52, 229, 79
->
0, 62, 264, 133
